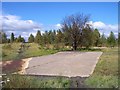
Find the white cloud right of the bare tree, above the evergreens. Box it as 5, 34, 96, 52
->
89, 21, 118, 37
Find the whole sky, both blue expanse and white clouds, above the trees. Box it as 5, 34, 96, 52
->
0, 2, 118, 39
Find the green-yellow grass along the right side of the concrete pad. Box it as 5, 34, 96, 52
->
85, 48, 118, 88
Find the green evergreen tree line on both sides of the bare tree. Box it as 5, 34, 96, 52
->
0, 29, 120, 47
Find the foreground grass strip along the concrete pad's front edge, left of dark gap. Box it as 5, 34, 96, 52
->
3, 75, 70, 88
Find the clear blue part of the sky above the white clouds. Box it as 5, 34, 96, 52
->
2, 2, 118, 24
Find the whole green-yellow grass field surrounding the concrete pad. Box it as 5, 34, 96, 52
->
2, 43, 120, 88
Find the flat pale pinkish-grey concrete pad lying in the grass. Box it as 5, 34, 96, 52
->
25, 51, 102, 77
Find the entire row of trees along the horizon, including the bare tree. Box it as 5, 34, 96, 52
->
0, 14, 120, 50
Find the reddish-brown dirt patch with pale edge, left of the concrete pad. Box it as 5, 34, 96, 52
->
0, 58, 32, 74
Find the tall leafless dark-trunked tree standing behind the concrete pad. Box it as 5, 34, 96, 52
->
62, 14, 89, 50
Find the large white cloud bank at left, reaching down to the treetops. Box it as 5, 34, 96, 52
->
0, 15, 43, 40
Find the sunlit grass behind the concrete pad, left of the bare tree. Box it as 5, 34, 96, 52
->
0, 43, 59, 61
